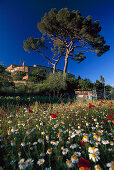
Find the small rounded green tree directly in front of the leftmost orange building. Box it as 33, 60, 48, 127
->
12, 71, 26, 81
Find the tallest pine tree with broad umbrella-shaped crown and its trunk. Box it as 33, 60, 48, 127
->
38, 8, 110, 72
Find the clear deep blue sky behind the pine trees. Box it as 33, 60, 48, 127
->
0, 0, 114, 86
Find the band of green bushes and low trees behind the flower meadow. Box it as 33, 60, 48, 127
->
0, 65, 114, 98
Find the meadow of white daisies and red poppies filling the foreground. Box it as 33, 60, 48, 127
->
0, 101, 114, 170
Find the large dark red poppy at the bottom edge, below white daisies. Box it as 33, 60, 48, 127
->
78, 157, 90, 170
